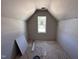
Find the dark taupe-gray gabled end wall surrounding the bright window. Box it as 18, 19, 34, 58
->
26, 10, 57, 40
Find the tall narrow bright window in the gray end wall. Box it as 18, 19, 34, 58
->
38, 16, 46, 33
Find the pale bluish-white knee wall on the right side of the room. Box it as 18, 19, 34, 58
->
58, 19, 78, 59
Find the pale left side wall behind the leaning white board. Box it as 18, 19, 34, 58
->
1, 17, 24, 59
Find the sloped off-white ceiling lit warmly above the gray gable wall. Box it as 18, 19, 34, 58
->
1, 0, 78, 20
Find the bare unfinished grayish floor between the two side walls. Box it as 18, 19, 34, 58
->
16, 41, 71, 59
